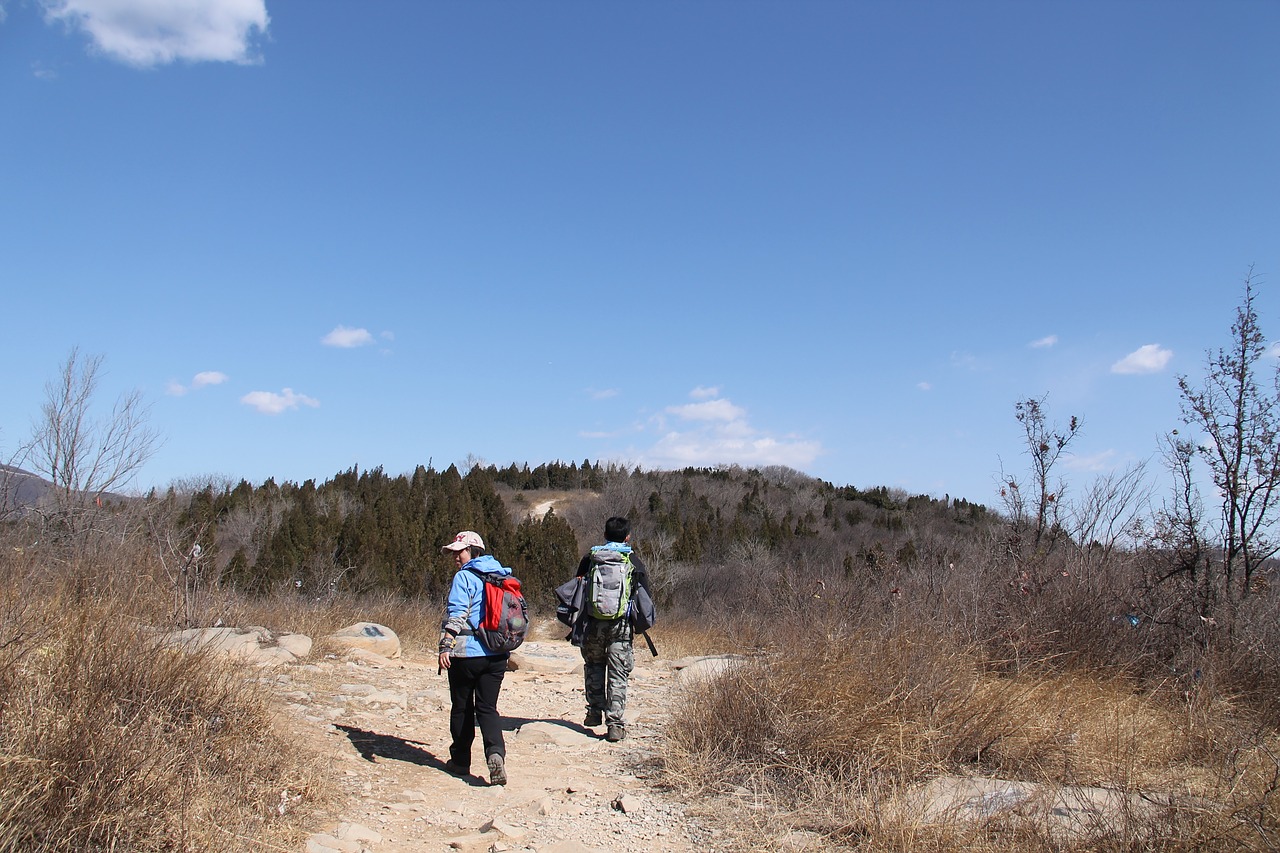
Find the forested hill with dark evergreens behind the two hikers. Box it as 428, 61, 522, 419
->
163, 461, 997, 606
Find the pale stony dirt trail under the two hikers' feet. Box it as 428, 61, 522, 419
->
280, 625, 718, 853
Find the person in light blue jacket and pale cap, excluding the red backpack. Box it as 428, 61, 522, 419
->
440, 530, 511, 785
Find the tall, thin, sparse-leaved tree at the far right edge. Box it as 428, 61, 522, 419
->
1178, 268, 1280, 598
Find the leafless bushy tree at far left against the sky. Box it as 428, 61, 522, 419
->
29, 348, 159, 533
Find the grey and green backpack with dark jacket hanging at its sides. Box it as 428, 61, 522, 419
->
556, 542, 657, 646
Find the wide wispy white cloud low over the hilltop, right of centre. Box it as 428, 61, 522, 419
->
632, 387, 822, 469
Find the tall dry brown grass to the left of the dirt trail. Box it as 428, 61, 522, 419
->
0, 525, 326, 852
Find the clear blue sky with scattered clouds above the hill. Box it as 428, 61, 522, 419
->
0, 0, 1280, 505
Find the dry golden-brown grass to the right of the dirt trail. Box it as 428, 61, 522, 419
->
666, 617, 1280, 850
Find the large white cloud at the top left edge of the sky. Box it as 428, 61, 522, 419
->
44, 0, 270, 68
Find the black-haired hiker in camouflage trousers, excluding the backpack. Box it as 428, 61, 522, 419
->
572, 516, 650, 742
